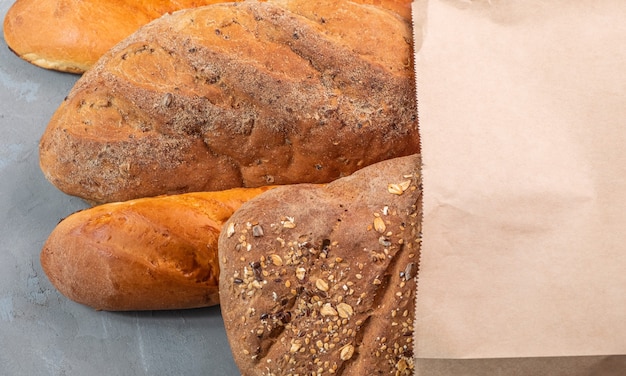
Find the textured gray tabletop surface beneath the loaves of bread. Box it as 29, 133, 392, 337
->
0, 0, 239, 376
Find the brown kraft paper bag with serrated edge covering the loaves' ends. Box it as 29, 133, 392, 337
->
413, 0, 626, 376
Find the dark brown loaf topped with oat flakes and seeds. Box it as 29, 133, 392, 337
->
219, 155, 421, 376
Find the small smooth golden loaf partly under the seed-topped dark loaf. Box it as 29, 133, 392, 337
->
40, 187, 270, 311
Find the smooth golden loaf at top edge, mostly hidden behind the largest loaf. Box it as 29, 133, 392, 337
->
4, 0, 411, 73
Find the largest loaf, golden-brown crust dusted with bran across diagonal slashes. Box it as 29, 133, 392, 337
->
40, 0, 419, 203
